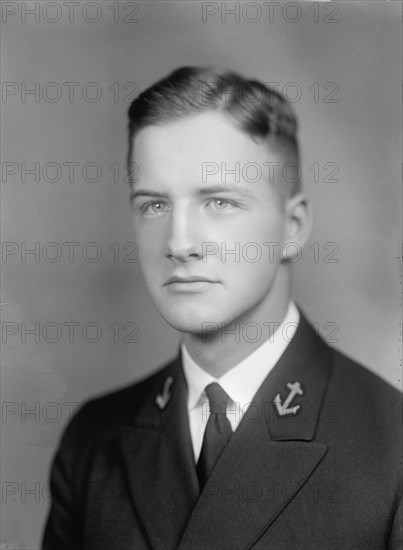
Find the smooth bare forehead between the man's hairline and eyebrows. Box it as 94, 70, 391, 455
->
133, 112, 276, 185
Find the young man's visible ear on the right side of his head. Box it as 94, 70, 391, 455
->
282, 193, 313, 262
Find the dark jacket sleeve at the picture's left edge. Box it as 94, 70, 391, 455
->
41, 405, 92, 550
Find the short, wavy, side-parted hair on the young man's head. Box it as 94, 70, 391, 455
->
128, 67, 301, 198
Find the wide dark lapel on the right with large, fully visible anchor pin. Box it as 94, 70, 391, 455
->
178, 316, 332, 550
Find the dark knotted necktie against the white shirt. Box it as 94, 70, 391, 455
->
197, 382, 232, 487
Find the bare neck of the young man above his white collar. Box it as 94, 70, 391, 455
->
183, 272, 290, 378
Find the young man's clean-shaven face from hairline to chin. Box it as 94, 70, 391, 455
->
133, 112, 286, 333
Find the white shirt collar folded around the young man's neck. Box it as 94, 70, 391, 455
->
181, 302, 300, 411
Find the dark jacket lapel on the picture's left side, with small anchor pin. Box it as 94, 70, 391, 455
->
119, 357, 199, 550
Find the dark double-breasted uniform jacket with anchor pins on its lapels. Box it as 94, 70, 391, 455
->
42, 316, 403, 550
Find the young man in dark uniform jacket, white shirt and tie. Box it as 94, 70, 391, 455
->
43, 68, 402, 550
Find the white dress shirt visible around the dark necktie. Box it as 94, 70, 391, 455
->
181, 302, 300, 462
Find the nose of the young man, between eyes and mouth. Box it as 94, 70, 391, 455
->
166, 205, 201, 262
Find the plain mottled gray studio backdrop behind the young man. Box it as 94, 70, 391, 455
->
1, 1, 401, 549
